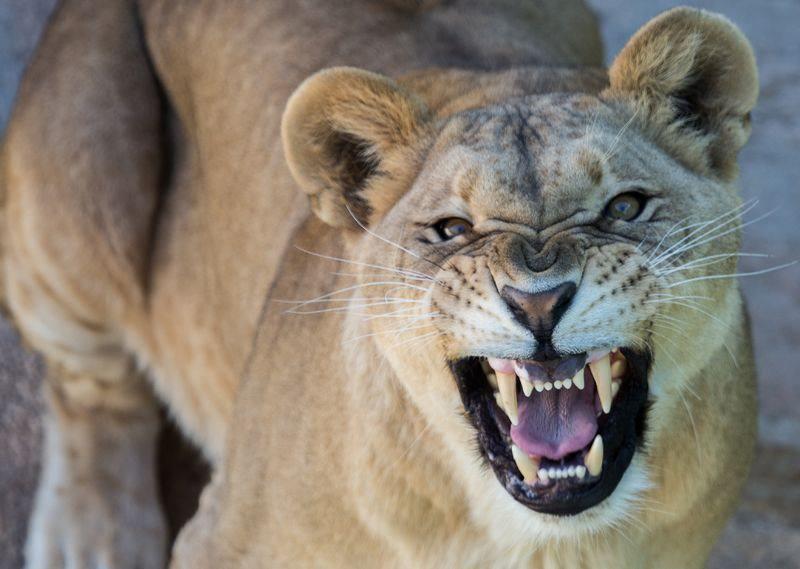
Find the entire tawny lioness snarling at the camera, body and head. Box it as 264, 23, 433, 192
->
2, 0, 757, 569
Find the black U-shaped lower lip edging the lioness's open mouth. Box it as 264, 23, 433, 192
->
450, 348, 652, 516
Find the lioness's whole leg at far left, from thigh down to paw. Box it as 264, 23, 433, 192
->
0, 0, 166, 569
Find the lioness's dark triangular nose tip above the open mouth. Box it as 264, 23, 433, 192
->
501, 282, 577, 345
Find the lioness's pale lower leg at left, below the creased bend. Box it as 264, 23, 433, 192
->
26, 361, 167, 569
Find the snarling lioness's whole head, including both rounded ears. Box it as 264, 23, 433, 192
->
284, 11, 756, 535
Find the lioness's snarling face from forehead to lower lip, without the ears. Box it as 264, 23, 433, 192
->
357, 95, 738, 524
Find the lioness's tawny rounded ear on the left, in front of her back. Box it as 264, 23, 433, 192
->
281, 67, 428, 227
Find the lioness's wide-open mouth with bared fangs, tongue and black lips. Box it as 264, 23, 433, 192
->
451, 348, 650, 515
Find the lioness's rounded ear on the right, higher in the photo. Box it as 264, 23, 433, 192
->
606, 8, 758, 179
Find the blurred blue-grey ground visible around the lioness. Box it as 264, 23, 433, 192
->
0, 0, 800, 569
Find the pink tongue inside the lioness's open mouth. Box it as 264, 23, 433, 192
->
511, 381, 597, 460
